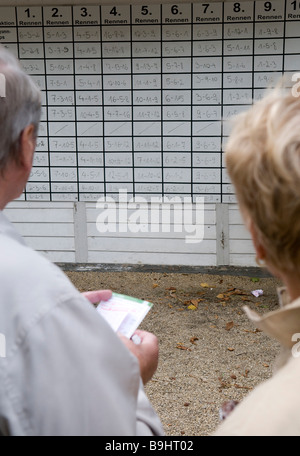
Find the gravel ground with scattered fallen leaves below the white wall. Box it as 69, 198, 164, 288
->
66, 271, 281, 436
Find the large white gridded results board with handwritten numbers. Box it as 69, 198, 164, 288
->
0, 0, 300, 203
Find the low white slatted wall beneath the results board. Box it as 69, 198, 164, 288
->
5, 201, 255, 266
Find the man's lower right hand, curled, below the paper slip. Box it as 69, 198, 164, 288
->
118, 330, 159, 385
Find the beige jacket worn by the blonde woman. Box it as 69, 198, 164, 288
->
215, 288, 300, 436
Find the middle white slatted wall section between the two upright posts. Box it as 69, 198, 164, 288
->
87, 203, 216, 266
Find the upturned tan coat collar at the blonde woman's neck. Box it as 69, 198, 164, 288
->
244, 288, 300, 348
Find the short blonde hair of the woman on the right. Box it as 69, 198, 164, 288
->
226, 89, 300, 273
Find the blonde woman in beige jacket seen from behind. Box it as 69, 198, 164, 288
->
216, 85, 300, 436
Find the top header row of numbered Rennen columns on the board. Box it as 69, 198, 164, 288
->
0, 0, 300, 27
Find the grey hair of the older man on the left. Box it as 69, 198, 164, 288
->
0, 46, 41, 173
